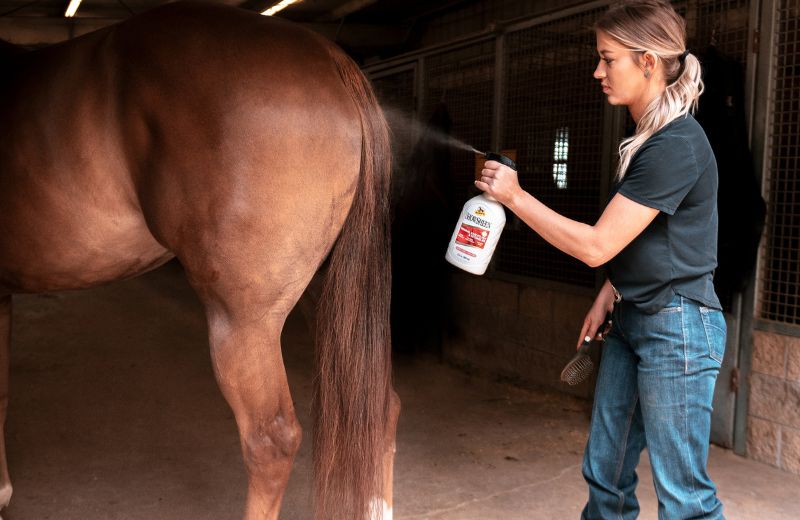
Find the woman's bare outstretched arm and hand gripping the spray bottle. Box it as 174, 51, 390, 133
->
475, 161, 658, 267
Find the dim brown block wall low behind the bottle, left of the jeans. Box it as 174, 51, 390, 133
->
442, 272, 594, 398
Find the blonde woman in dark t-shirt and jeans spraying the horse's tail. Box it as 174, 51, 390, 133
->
476, 0, 726, 519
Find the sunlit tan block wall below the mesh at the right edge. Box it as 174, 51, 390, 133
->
747, 330, 800, 475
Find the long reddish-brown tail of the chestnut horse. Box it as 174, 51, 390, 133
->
313, 48, 391, 520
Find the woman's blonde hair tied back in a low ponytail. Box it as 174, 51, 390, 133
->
595, 0, 703, 181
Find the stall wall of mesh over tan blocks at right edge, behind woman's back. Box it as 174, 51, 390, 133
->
737, 0, 800, 474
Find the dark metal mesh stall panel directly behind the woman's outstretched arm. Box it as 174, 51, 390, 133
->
496, 6, 605, 288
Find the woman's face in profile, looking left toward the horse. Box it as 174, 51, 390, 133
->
594, 30, 653, 113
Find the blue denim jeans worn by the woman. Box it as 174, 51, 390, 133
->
581, 296, 726, 520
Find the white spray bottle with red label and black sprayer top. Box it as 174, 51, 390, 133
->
445, 152, 517, 275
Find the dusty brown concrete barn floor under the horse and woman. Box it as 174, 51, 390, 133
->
3, 264, 800, 520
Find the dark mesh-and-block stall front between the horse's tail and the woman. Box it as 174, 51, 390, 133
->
368, 2, 621, 397
